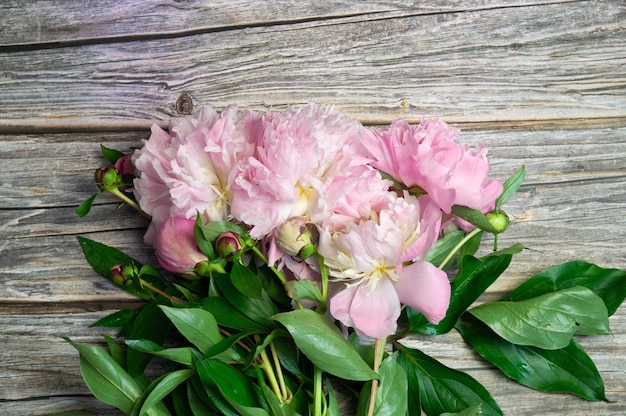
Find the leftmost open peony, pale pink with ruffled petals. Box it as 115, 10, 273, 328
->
133, 106, 254, 243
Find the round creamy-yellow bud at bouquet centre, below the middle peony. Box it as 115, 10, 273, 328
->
276, 217, 320, 259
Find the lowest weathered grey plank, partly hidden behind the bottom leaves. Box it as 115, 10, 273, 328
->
0, 306, 626, 416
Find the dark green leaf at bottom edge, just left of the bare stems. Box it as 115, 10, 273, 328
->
196, 358, 269, 416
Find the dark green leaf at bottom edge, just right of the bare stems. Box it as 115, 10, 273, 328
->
394, 343, 502, 416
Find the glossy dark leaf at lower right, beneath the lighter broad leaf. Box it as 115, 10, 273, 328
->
456, 314, 606, 401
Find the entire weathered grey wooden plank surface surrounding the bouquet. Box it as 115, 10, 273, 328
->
0, 0, 626, 415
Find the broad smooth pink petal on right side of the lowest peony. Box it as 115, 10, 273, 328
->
394, 261, 451, 324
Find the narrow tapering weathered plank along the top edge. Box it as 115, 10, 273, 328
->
0, 0, 572, 46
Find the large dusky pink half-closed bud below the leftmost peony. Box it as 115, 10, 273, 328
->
154, 217, 207, 279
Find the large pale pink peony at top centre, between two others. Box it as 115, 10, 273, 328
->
231, 104, 371, 239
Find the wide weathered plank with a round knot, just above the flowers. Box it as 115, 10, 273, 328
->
0, 1, 626, 131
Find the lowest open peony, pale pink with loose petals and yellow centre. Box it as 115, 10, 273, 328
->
318, 194, 450, 338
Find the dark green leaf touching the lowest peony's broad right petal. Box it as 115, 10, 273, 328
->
407, 254, 512, 335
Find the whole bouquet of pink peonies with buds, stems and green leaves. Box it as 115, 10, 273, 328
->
68, 104, 626, 416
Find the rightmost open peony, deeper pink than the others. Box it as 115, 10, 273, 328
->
364, 119, 502, 214
